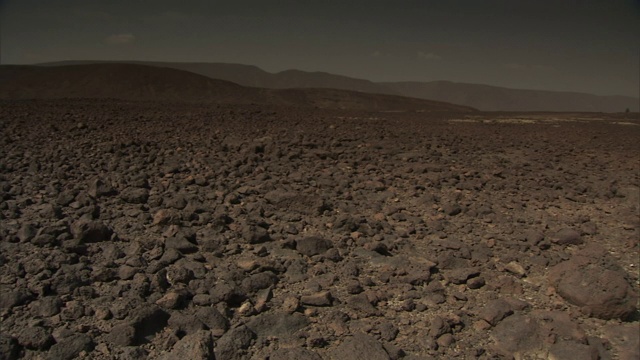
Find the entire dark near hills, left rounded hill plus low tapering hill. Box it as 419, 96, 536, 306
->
0, 63, 475, 112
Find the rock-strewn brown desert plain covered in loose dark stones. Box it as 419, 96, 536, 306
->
0, 101, 640, 360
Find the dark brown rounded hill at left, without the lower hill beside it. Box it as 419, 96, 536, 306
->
0, 64, 259, 102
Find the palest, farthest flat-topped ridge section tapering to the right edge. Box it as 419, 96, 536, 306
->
383, 81, 639, 112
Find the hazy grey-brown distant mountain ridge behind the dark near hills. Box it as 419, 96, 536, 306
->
33, 61, 640, 112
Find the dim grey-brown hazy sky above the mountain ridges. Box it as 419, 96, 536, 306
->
0, 0, 640, 97
